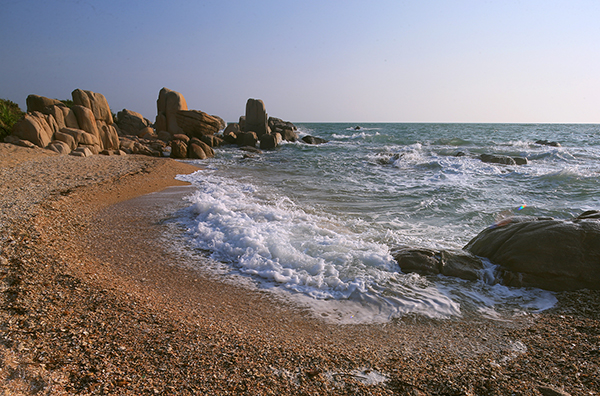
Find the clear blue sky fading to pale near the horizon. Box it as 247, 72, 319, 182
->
0, 0, 600, 123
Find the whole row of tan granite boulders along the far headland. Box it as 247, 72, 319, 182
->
4, 88, 326, 159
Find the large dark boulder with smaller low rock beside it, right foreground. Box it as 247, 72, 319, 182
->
393, 211, 600, 291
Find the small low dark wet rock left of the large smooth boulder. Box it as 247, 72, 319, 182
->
392, 248, 484, 280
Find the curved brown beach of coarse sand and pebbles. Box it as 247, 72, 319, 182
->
0, 143, 600, 395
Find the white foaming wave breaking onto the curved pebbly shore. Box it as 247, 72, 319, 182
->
180, 171, 560, 323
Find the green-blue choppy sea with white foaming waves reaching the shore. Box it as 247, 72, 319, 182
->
172, 123, 600, 323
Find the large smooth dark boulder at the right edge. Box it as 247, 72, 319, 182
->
464, 211, 600, 291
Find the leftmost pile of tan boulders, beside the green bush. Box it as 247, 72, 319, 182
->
8, 89, 119, 154
